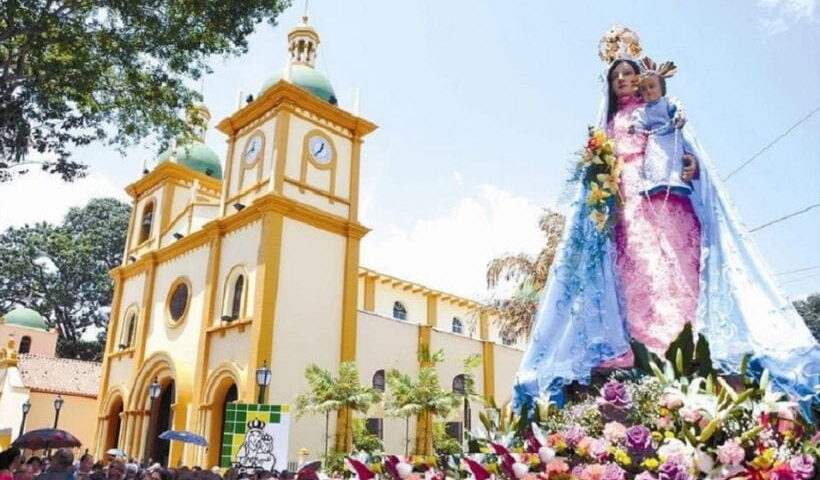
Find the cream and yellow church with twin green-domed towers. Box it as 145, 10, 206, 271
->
89, 16, 521, 466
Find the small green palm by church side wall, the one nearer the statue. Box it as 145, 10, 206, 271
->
387, 349, 463, 455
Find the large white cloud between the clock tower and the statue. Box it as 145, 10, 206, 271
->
361, 185, 544, 300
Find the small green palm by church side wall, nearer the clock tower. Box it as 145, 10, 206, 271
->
296, 362, 381, 456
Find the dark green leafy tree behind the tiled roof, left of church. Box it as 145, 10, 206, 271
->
0, 198, 131, 361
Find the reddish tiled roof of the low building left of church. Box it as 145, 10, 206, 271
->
17, 354, 102, 398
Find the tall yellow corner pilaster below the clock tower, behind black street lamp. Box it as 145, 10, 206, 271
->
243, 211, 287, 403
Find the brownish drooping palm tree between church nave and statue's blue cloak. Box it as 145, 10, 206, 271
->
481, 209, 564, 338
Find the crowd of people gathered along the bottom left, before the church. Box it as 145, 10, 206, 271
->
0, 447, 320, 480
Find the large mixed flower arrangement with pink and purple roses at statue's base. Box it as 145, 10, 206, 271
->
342, 328, 820, 480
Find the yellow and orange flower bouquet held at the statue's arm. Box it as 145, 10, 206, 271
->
580, 127, 622, 234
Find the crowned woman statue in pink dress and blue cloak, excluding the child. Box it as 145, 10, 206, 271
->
514, 27, 820, 412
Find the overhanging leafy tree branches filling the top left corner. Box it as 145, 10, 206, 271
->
0, 0, 290, 181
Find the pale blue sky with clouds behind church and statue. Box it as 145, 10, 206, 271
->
0, 0, 820, 298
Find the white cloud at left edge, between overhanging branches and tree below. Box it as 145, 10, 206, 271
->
0, 170, 128, 232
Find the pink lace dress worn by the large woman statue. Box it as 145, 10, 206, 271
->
607, 97, 700, 356
